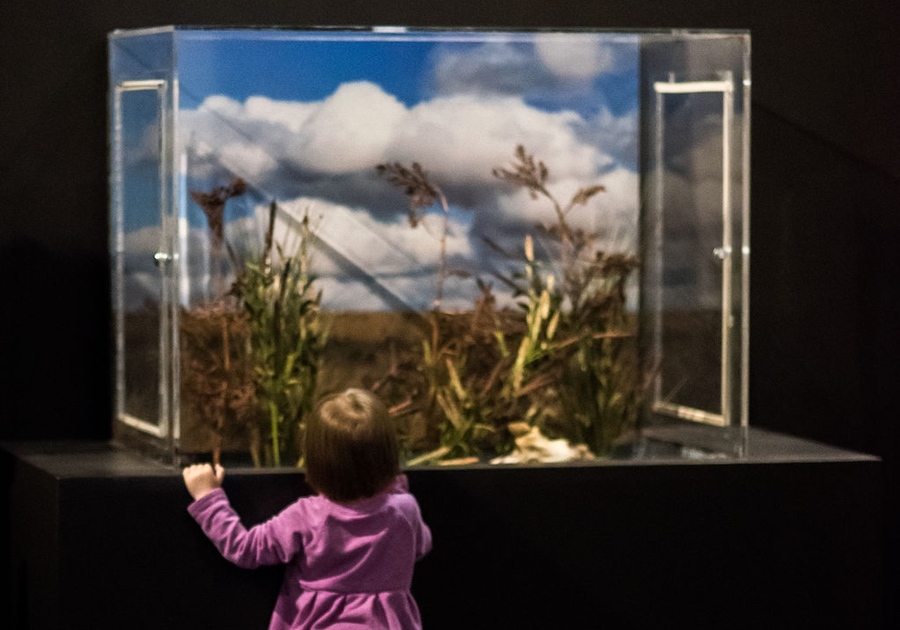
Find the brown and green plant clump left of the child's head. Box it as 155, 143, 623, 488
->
180, 195, 325, 466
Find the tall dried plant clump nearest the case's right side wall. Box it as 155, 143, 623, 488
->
493, 145, 641, 455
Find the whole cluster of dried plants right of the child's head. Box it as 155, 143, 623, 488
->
378, 145, 641, 463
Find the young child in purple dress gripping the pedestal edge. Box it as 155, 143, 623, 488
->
184, 389, 431, 630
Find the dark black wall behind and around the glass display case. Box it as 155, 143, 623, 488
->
0, 0, 900, 627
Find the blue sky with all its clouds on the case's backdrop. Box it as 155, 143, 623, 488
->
116, 30, 639, 308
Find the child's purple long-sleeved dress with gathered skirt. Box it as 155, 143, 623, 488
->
188, 475, 431, 630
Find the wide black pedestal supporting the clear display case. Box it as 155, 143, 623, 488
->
2, 430, 882, 630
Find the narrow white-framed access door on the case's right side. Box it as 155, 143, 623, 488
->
654, 78, 732, 424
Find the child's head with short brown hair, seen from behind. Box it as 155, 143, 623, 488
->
304, 389, 400, 501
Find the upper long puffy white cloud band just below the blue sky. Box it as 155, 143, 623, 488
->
182, 82, 624, 184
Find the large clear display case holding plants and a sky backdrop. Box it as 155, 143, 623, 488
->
109, 26, 750, 466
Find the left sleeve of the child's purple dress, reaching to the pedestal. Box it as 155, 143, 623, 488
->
188, 488, 303, 569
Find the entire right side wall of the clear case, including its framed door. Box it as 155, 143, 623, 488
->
641, 31, 750, 446
